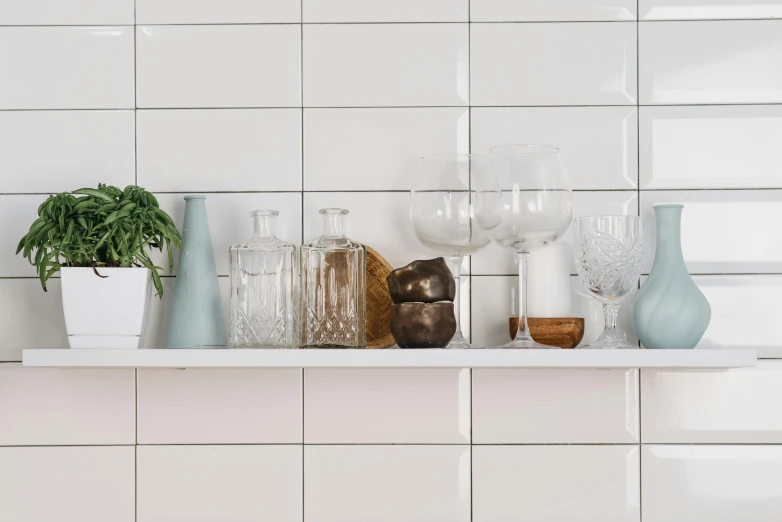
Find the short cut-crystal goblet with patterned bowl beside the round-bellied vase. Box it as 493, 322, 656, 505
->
575, 216, 644, 348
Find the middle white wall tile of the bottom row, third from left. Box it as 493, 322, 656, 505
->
306, 446, 470, 522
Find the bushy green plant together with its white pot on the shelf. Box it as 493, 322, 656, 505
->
16, 184, 182, 348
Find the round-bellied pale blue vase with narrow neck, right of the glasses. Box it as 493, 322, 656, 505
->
630, 204, 711, 349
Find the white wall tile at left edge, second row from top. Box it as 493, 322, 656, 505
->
0, 27, 134, 109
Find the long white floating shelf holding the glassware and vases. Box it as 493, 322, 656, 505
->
22, 348, 757, 370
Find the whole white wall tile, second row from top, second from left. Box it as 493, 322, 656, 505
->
136, 25, 301, 108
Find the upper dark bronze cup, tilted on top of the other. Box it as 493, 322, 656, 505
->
386, 257, 456, 303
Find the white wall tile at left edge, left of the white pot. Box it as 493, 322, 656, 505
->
0, 278, 68, 361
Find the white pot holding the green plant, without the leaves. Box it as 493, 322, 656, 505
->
61, 268, 153, 349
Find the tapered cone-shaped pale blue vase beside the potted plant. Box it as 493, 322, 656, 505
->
167, 195, 225, 348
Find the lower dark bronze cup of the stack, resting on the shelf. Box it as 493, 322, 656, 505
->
391, 301, 456, 348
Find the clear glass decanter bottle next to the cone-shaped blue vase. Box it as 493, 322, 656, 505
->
228, 210, 300, 348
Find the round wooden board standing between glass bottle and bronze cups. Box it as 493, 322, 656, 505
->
364, 245, 395, 348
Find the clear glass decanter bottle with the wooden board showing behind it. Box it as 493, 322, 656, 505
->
301, 208, 367, 348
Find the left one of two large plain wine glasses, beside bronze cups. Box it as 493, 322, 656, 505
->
410, 154, 492, 348
